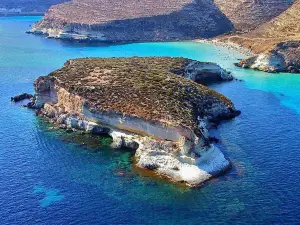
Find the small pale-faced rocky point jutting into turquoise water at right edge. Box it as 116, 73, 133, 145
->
236, 41, 300, 73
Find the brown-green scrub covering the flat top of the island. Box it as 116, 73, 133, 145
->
48, 57, 233, 128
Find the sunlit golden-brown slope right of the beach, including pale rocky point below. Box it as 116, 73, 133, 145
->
218, 0, 300, 73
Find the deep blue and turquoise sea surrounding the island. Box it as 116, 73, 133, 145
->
0, 17, 300, 225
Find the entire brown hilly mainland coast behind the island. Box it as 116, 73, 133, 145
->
23, 0, 300, 73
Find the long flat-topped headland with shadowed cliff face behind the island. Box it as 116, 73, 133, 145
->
31, 0, 233, 42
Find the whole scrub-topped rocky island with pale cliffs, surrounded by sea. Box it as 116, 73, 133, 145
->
33, 57, 240, 186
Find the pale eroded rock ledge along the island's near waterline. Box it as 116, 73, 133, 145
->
37, 105, 235, 187
